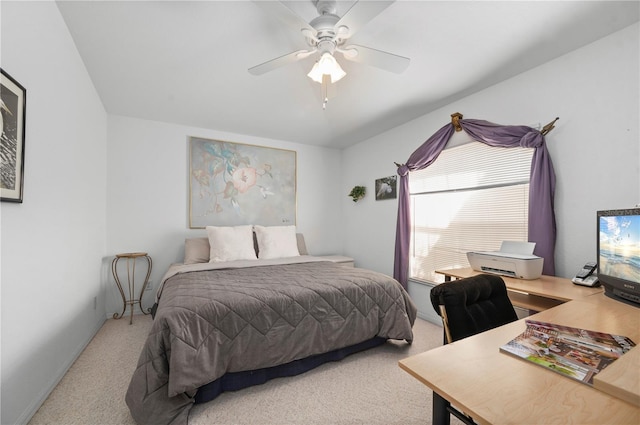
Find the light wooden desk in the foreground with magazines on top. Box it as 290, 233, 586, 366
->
399, 294, 640, 424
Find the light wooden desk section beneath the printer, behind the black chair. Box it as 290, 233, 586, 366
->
436, 267, 603, 311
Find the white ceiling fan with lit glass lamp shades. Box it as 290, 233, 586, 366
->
249, 0, 410, 84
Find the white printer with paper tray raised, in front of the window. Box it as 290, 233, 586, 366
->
467, 241, 544, 279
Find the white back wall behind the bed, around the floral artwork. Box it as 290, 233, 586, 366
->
105, 115, 343, 313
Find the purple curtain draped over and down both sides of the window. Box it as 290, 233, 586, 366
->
393, 119, 556, 288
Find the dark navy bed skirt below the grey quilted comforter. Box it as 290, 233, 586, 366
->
195, 337, 387, 404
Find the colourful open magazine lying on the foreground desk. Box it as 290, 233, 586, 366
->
500, 320, 635, 385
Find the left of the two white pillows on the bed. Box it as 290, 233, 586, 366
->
207, 225, 256, 263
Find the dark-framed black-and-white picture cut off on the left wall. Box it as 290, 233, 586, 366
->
0, 69, 27, 202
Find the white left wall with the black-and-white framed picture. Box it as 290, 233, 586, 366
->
0, 1, 107, 424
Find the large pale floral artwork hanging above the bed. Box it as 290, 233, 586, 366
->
189, 137, 297, 229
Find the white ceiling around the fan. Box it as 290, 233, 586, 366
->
57, 0, 640, 147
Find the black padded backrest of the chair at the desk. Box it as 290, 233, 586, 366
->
431, 274, 518, 342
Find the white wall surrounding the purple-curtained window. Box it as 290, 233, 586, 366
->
342, 23, 640, 314
